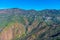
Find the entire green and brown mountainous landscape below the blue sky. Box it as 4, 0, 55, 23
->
0, 8, 60, 40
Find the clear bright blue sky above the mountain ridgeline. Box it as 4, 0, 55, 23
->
0, 0, 60, 10
